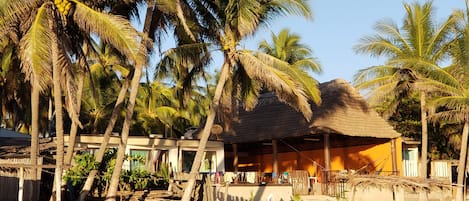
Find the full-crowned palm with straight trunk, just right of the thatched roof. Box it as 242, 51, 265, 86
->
354, 2, 455, 178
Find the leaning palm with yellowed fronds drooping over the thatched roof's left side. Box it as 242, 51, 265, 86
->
182, 0, 319, 201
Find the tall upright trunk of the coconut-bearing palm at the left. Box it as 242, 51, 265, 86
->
51, 31, 64, 201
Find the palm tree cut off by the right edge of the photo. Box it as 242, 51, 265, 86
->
428, 3, 469, 201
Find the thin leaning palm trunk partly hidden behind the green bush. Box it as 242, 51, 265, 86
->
79, 78, 129, 201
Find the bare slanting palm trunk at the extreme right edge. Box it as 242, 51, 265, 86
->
456, 121, 469, 201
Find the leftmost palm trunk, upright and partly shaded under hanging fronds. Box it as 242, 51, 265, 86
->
30, 80, 39, 181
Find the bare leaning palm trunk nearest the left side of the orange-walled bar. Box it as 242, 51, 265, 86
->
181, 61, 230, 201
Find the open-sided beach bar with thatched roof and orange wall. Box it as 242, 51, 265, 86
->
221, 79, 402, 195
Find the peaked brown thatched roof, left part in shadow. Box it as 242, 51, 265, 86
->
221, 79, 400, 143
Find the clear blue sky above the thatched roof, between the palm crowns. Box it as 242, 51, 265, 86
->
239, 0, 465, 82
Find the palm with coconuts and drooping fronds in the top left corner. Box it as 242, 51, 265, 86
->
0, 0, 146, 200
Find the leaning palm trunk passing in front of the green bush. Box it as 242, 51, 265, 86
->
106, 64, 143, 200
